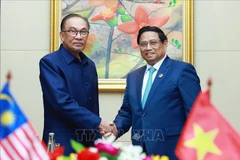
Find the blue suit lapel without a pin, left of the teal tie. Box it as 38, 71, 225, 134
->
136, 66, 146, 108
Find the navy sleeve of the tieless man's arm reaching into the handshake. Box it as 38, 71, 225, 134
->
39, 58, 101, 129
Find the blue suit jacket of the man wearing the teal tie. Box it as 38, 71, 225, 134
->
114, 56, 201, 160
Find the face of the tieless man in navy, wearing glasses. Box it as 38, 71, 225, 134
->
60, 17, 88, 57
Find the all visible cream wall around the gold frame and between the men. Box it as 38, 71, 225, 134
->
0, 0, 240, 142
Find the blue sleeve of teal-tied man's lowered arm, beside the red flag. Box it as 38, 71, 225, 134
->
178, 64, 201, 116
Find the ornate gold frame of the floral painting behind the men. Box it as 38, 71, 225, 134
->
50, 0, 194, 92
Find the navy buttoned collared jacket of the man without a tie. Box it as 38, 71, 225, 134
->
40, 45, 101, 155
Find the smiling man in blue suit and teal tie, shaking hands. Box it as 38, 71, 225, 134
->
105, 26, 201, 160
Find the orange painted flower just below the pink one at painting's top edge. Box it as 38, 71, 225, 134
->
91, 6, 121, 22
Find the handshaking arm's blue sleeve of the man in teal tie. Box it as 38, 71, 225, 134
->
114, 76, 132, 137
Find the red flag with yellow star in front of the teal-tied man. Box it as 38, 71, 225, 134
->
175, 90, 240, 160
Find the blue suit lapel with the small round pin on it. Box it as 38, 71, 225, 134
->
144, 56, 171, 110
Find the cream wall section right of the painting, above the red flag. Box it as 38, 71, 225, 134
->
194, 0, 240, 132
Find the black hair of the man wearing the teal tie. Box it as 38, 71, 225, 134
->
137, 26, 167, 44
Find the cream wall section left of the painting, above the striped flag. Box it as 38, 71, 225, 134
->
0, 0, 50, 135
